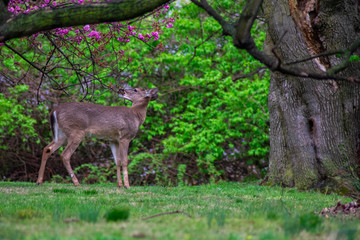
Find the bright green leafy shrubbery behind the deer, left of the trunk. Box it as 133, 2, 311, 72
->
0, 1, 269, 186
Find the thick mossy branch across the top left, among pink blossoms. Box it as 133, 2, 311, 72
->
0, 0, 171, 42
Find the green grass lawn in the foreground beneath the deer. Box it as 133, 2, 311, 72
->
0, 182, 360, 240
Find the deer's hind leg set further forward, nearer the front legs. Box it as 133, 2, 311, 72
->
61, 131, 85, 186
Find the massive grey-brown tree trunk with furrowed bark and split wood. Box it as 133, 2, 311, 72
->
264, 0, 360, 194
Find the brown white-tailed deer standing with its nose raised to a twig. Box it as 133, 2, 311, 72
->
36, 86, 158, 188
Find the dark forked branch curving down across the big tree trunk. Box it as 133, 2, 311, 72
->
191, 0, 360, 83
